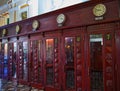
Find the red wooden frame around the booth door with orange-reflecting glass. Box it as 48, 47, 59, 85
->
43, 31, 61, 91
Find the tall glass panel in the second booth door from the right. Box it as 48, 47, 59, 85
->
65, 37, 75, 88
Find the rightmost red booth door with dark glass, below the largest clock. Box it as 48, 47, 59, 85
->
88, 32, 115, 91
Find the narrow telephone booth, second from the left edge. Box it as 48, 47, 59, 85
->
8, 37, 18, 81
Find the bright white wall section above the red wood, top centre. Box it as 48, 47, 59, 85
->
38, 0, 89, 14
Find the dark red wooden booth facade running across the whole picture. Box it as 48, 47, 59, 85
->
0, 0, 120, 91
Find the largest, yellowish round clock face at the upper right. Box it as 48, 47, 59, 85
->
93, 4, 106, 16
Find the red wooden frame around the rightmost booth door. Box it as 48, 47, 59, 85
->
87, 29, 115, 91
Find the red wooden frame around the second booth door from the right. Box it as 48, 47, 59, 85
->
61, 27, 86, 91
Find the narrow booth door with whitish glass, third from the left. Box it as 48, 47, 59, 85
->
17, 41, 28, 84
